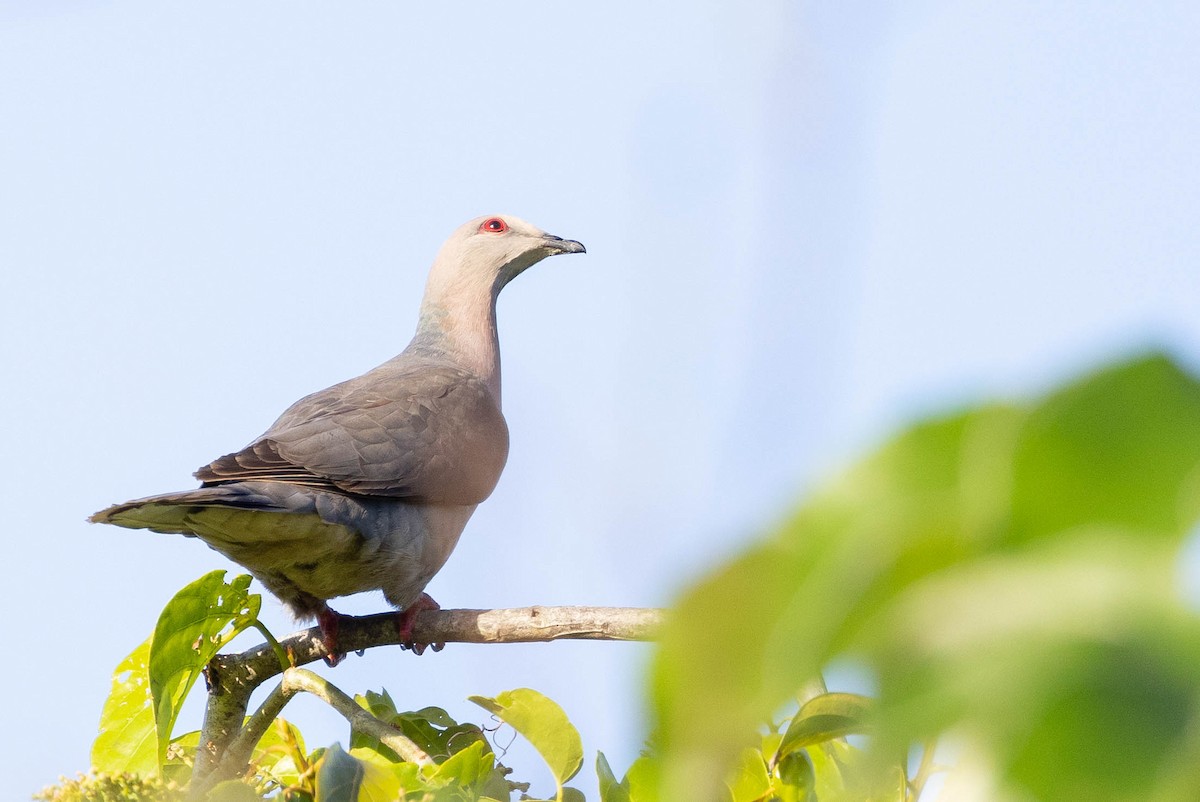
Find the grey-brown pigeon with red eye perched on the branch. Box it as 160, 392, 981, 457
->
89, 215, 587, 664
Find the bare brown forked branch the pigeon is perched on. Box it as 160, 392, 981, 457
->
193, 606, 662, 786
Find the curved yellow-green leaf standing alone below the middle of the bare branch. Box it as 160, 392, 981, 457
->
469, 688, 583, 792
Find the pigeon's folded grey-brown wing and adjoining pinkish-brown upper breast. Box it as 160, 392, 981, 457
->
196, 355, 509, 504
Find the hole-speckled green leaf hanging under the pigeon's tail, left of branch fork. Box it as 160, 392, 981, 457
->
149, 570, 262, 765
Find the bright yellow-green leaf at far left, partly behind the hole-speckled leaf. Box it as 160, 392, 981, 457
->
91, 638, 158, 776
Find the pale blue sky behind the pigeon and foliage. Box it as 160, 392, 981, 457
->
0, 0, 1200, 792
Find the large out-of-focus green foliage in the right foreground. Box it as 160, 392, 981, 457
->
654, 355, 1200, 800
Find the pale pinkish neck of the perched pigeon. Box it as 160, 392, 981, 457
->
407, 285, 500, 405
